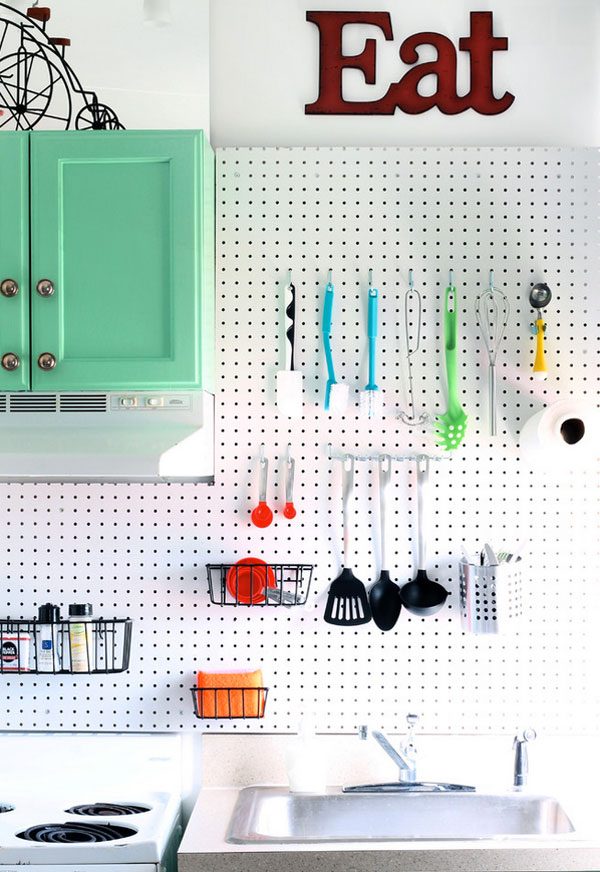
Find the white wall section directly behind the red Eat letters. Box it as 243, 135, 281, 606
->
211, 0, 600, 146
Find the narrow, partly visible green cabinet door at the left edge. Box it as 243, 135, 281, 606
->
0, 131, 29, 391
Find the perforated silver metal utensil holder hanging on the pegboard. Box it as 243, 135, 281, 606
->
459, 558, 523, 635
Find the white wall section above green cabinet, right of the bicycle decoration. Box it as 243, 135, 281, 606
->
8, 0, 210, 129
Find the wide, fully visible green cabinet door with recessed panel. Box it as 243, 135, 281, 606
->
31, 131, 213, 391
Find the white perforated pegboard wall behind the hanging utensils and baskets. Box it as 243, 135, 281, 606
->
0, 148, 600, 732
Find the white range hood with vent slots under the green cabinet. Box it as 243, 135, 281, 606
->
0, 391, 214, 483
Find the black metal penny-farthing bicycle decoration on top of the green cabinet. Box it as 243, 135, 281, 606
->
0, 3, 123, 130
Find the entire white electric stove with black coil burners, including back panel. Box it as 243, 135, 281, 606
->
0, 733, 182, 872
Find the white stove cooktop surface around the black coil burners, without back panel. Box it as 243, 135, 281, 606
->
0, 784, 179, 869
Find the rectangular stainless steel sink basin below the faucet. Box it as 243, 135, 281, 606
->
227, 787, 573, 844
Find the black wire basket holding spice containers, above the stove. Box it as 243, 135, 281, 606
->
0, 618, 132, 675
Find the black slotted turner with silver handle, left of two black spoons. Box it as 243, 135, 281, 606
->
325, 457, 371, 627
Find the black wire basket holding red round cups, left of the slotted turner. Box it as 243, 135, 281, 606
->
206, 557, 314, 607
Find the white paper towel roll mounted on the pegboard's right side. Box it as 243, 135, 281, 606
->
519, 399, 600, 469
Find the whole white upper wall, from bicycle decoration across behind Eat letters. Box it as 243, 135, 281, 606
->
12, 0, 600, 146
